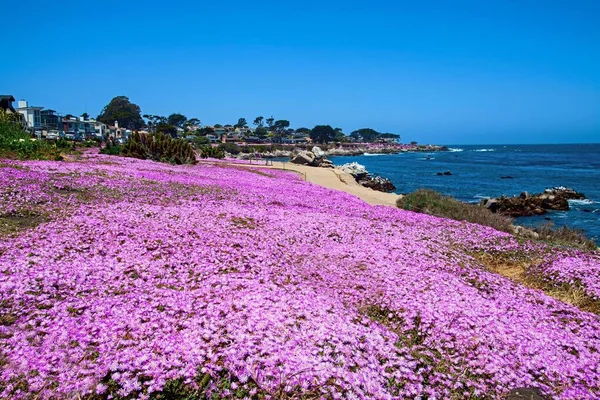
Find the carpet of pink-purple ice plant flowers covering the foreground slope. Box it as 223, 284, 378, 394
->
0, 155, 600, 399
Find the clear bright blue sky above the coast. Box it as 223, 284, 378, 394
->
0, 0, 600, 144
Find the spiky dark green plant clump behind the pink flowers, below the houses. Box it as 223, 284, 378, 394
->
121, 132, 197, 164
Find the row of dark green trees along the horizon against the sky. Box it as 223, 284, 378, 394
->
97, 96, 400, 143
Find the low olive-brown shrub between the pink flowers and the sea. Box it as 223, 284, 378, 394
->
396, 189, 513, 233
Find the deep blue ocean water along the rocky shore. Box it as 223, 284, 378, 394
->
331, 144, 600, 244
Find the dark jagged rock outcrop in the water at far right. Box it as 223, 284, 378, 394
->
479, 186, 585, 217
